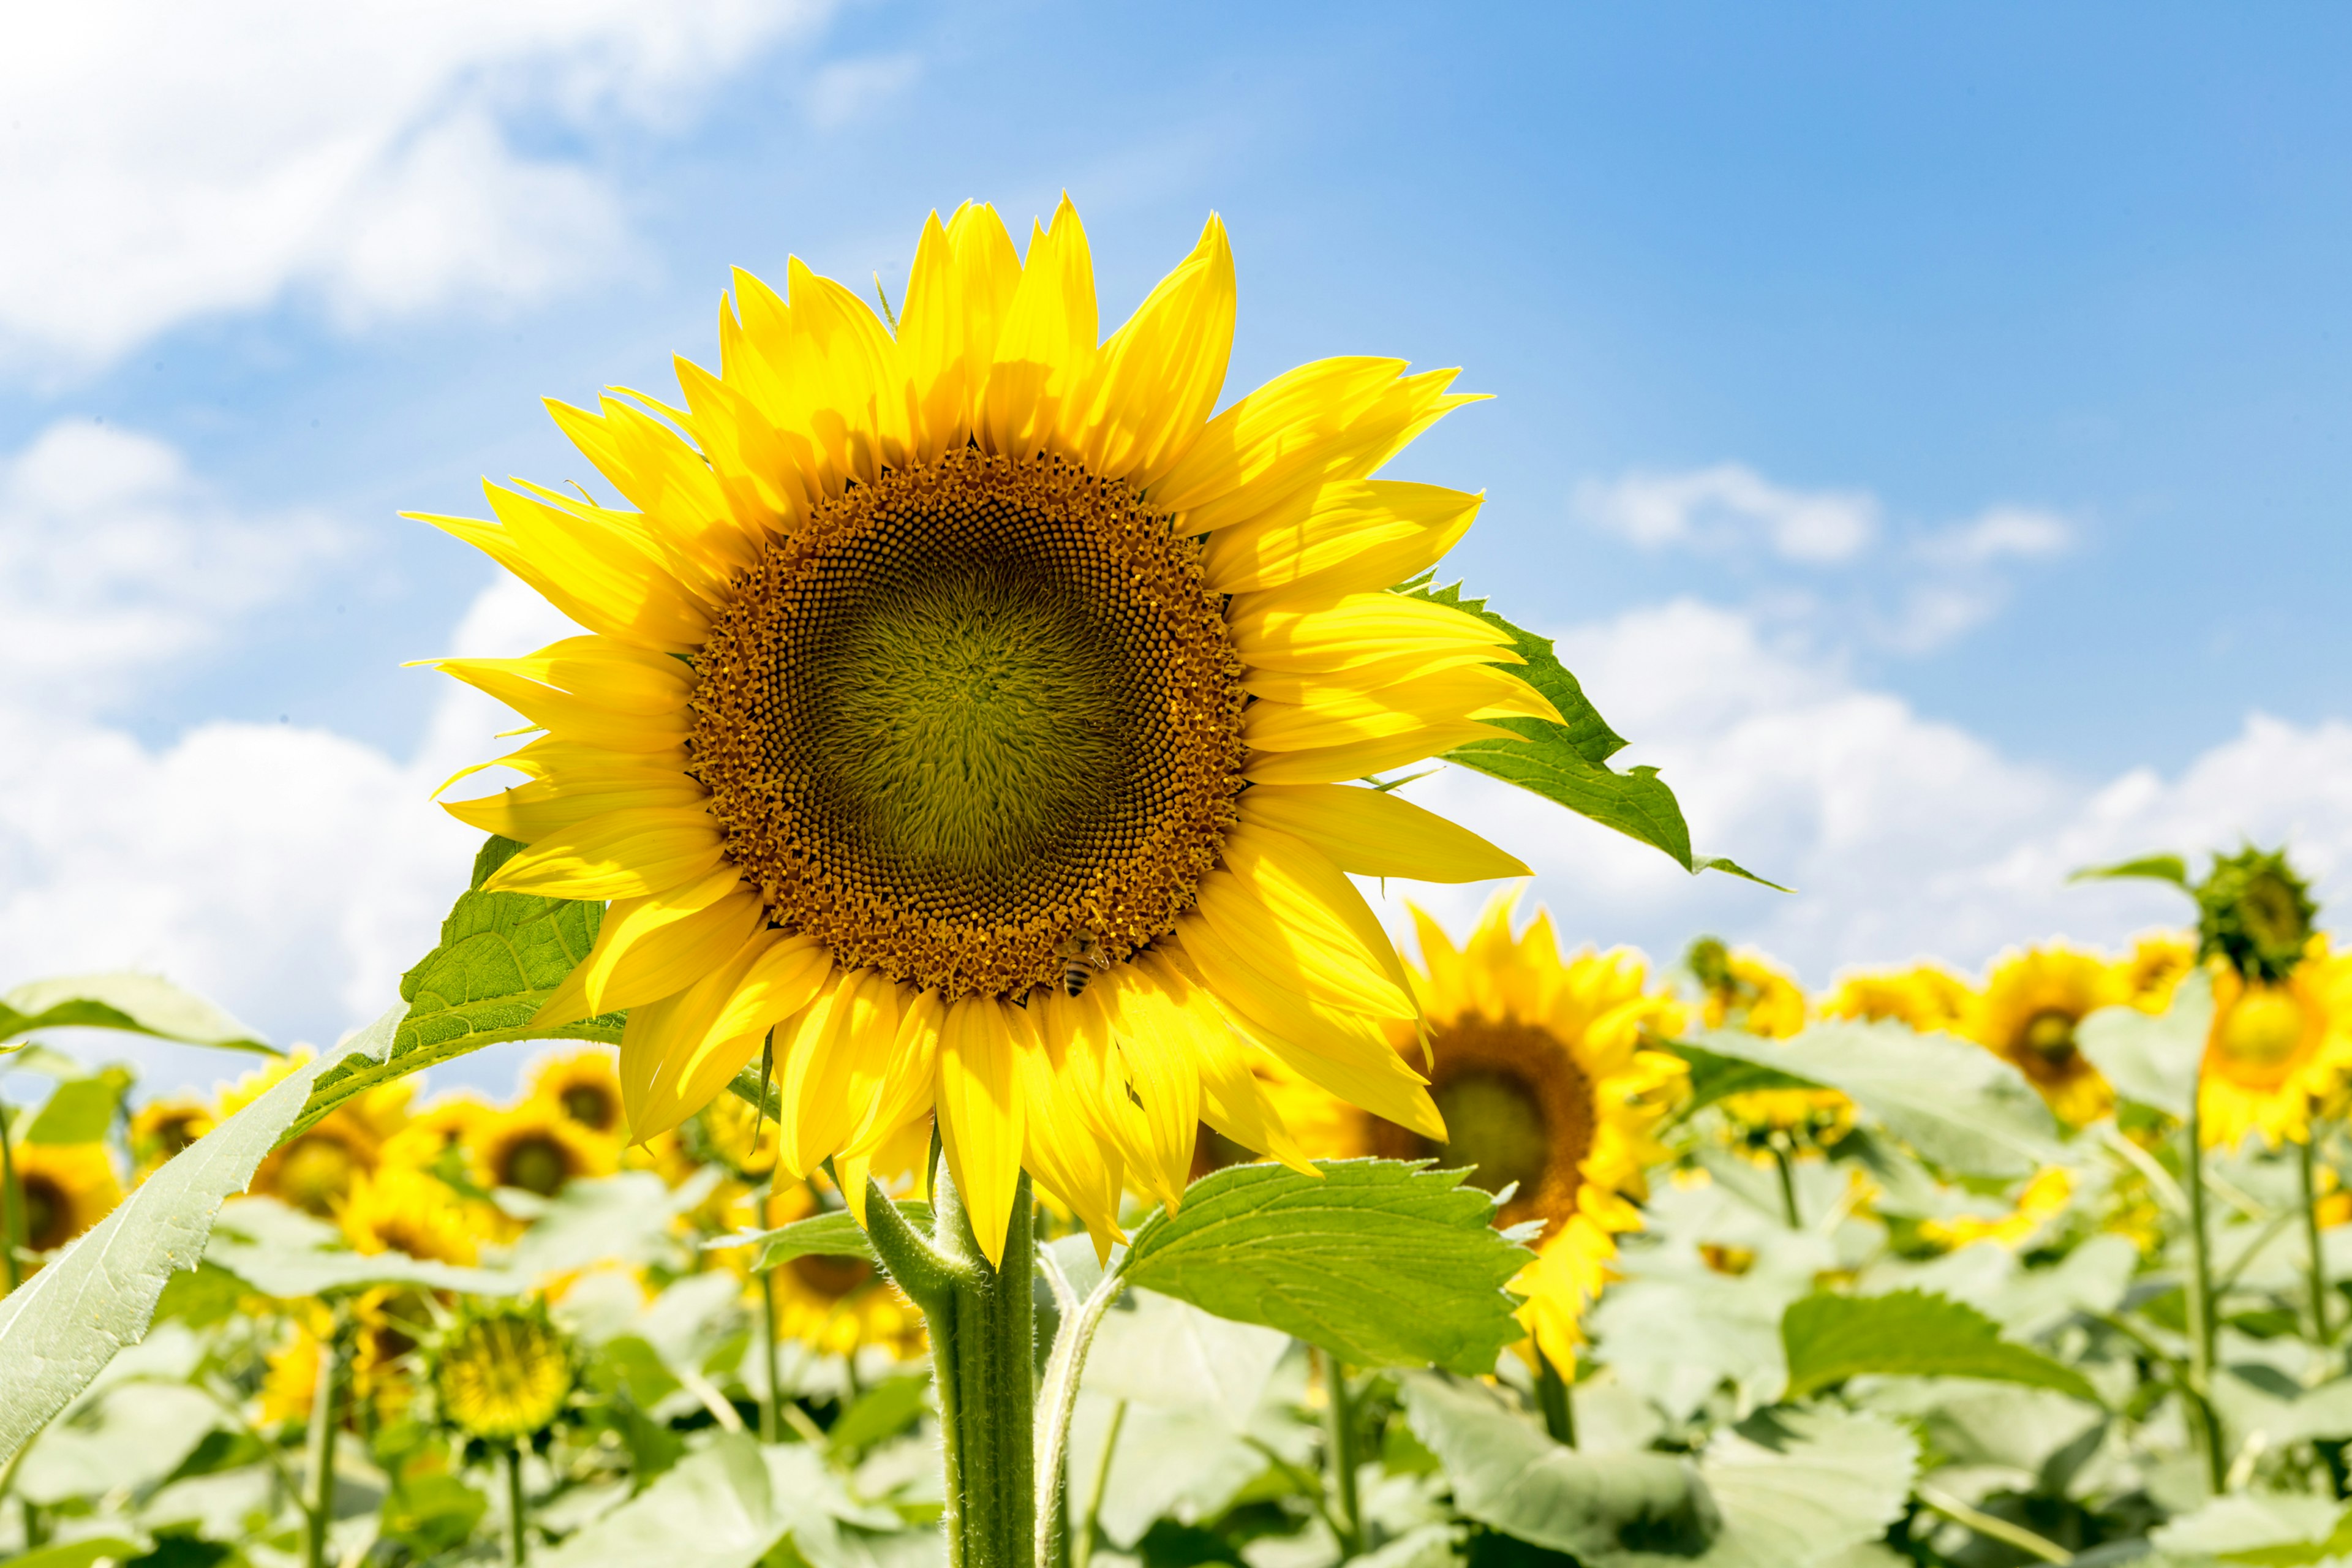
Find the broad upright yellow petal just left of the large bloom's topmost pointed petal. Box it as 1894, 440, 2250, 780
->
899, 202, 1021, 461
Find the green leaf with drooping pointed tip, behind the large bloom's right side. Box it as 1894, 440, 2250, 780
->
1406, 583, 1787, 893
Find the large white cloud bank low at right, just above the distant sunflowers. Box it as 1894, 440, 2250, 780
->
1388, 600, 2352, 982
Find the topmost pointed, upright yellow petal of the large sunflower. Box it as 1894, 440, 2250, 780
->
981, 195, 1096, 458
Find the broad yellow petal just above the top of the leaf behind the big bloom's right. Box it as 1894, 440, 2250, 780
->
1202, 480, 1484, 595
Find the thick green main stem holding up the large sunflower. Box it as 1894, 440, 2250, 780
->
865, 1159, 1037, 1568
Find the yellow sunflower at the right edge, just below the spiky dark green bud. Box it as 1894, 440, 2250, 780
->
2197, 936, 2352, 1150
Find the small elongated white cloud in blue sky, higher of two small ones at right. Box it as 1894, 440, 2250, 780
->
1576, 463, 1879, 564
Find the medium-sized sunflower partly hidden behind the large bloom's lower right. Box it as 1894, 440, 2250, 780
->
1343, 895, 1684, 1366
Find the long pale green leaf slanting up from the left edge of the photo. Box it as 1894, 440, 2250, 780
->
0, 1013, 395, 1462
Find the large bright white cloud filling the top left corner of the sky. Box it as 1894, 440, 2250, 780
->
0, 0, 831, 369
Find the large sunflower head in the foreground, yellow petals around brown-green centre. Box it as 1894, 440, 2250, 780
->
431, 200, 1557, 1257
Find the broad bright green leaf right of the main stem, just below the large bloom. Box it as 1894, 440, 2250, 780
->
1125, 1159, 1531, 1373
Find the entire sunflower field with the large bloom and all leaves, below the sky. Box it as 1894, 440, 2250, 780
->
0, 202, 2352, 1568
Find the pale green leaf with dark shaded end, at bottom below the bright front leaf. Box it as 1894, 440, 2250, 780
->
1404, 1373, 1722, 1563
